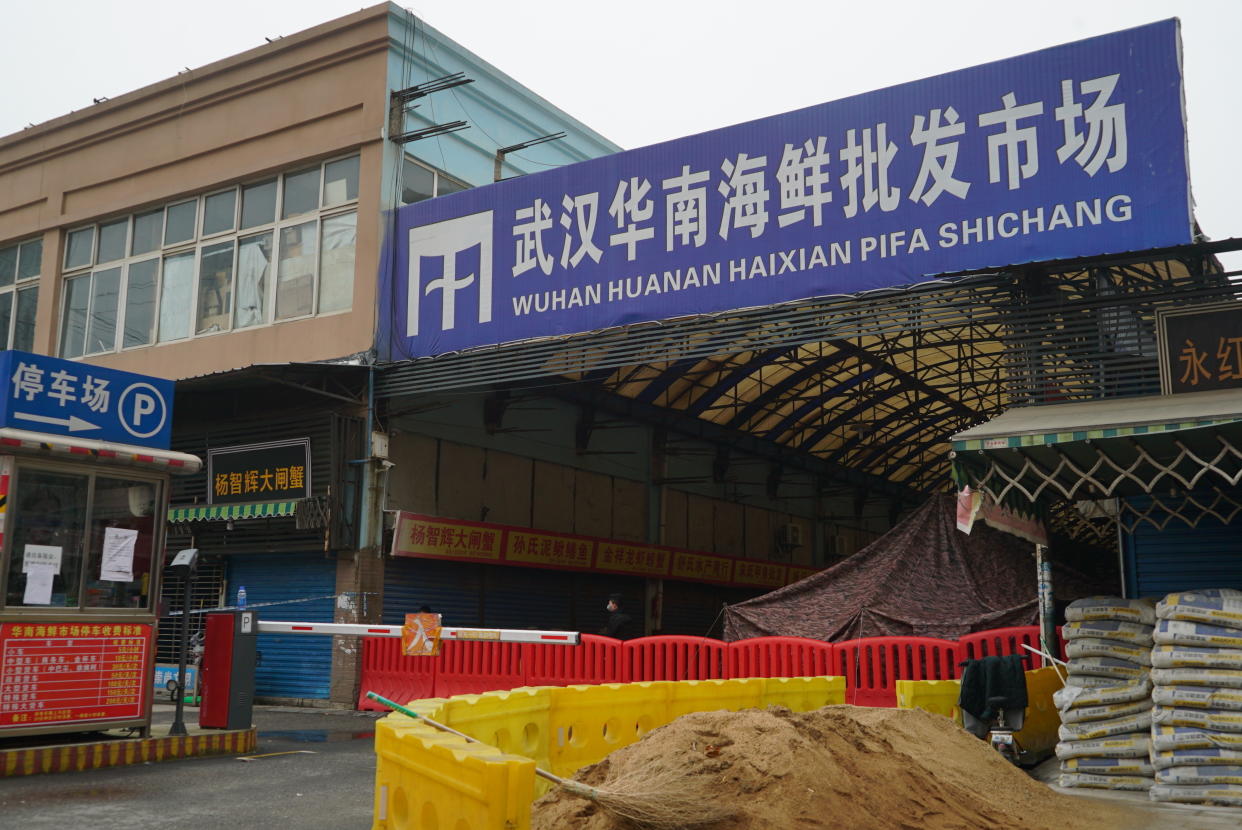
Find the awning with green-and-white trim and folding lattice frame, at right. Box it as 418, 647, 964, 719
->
951, 389, 1242, 504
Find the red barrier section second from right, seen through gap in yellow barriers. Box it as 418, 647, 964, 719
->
832, 637, 959, 706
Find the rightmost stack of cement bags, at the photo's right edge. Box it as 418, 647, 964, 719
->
1151, 589, 1242, 805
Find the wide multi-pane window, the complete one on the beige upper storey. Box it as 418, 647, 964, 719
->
58, 155, 359, 358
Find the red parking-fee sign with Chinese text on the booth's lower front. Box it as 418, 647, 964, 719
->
0, 623, 152, 729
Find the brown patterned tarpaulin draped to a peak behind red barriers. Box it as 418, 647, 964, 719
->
724, 495, 1078, 642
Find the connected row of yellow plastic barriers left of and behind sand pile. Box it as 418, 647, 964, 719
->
371, 677, 846, 830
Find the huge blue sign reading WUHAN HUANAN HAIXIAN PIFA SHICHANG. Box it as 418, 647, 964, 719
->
379, 20, 1192, 360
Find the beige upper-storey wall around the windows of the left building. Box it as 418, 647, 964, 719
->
0, 4, 389, 378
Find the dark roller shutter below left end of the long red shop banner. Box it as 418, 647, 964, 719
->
383, 557, 483, 627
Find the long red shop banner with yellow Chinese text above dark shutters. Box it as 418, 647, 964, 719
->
392, 511, 817, 588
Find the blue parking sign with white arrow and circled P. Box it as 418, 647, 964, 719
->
0, 350, 174, 450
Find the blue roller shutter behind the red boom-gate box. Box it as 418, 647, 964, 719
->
225, 553, 337, 698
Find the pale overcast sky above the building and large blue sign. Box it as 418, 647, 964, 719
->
7, 0, 1242, 268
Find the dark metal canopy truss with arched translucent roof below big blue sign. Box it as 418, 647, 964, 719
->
376, 241, 1242, 492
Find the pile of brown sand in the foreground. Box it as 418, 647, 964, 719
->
532, 706, 1143, 830
